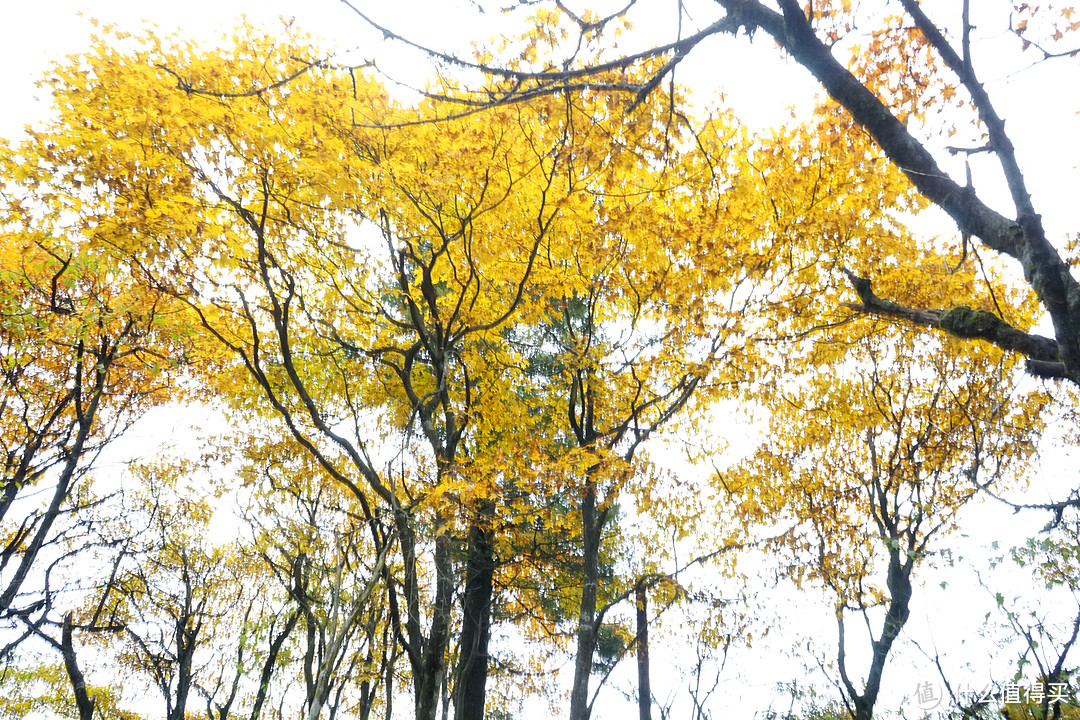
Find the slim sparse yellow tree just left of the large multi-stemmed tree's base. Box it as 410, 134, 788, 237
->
230, 433, 399, 719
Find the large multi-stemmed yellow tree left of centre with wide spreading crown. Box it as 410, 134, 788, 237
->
12, 23, 578, 718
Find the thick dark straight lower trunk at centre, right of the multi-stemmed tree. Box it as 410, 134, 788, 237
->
455, 524, 495, 720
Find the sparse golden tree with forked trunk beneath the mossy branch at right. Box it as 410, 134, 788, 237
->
719, 328, 1045, 720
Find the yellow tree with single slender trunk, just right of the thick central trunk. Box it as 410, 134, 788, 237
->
460, 73, 908, 717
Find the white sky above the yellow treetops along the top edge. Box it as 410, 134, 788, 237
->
6, 0, 1080, 225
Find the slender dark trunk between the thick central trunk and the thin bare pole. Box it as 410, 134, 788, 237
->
570, 480, 603, 720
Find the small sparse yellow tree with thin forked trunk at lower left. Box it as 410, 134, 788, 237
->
91, 464, 256, 720
